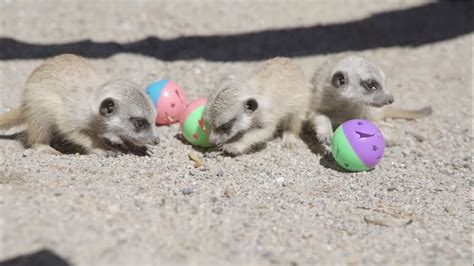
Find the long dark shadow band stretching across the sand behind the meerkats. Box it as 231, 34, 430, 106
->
0, 1, 474, 61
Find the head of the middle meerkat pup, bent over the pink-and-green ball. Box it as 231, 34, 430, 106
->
204, 80, 259, 145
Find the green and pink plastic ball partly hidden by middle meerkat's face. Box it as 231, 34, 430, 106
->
179, 98, 211, 147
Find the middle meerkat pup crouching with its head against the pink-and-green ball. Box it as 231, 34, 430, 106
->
204, 58, 312, 155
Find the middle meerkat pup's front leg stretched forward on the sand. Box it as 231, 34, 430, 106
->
222, 124, 276, 155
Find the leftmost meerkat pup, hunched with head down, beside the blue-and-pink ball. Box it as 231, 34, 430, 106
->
0, 54, 158, 155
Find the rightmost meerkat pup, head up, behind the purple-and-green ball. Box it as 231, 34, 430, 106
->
309, 55, 432, 152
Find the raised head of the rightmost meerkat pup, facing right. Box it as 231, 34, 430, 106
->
326, 55, 394, 107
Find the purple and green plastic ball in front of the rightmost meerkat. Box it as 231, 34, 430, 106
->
331, 119, 385, 172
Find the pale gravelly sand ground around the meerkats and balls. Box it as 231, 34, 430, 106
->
0, 0, 474, 265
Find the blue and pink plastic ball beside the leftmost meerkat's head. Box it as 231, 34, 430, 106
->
146, 79, 187, 125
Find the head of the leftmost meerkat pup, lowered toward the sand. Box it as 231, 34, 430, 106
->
96, 80, 159, 145
